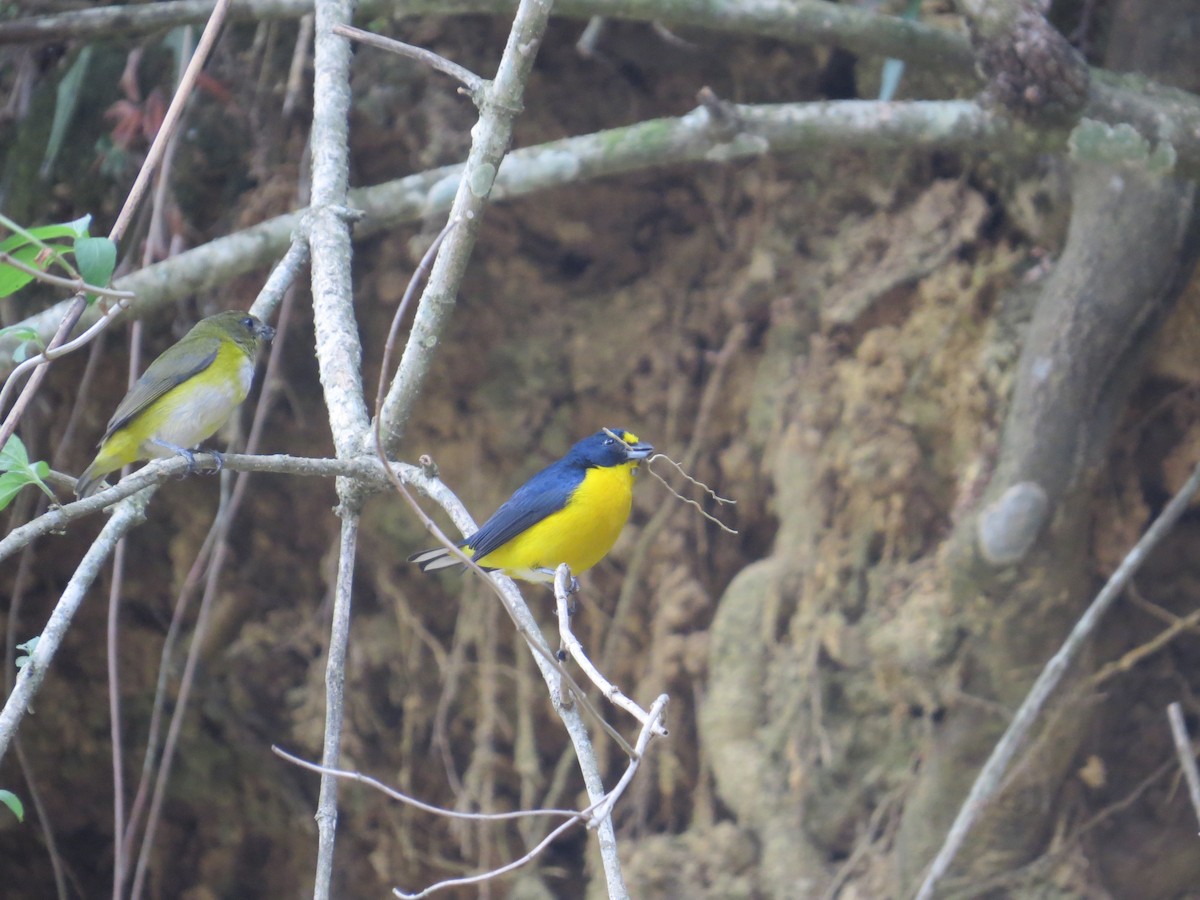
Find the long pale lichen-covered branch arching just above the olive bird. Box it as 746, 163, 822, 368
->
0, 101, 1041, 373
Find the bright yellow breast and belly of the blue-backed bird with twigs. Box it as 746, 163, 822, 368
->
478, 462, 637, 581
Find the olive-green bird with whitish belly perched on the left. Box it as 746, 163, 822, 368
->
76, 310, 275, 497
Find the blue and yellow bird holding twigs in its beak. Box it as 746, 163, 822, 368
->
408, 428, 654, 583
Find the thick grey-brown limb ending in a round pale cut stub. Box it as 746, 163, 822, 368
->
978, 167, 1196, 566
